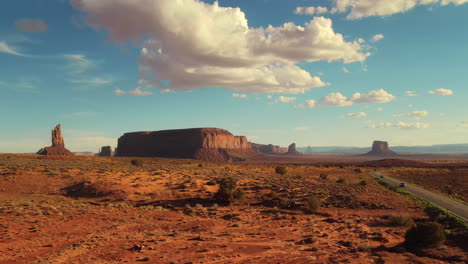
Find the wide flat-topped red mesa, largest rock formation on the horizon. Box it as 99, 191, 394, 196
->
115, 128, 254, 162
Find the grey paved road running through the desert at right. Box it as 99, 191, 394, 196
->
371, 171, 468, 221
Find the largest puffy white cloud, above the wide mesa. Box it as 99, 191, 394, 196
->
72, 0, 370, 94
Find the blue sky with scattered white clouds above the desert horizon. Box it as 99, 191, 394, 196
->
0, 0, 468, 152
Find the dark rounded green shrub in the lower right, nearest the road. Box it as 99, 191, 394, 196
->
405, 222, 445, 248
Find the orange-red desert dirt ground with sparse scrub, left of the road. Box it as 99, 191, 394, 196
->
0, 154, 468, 264
